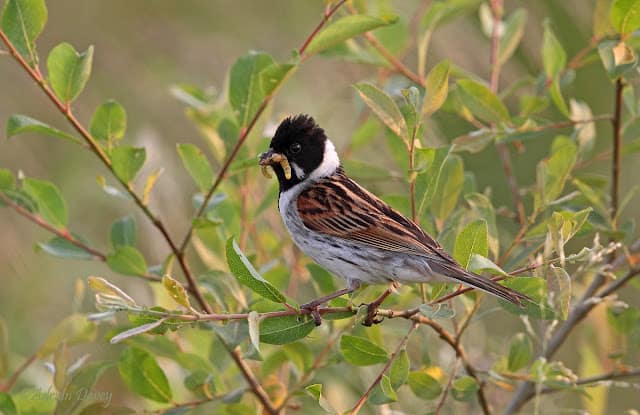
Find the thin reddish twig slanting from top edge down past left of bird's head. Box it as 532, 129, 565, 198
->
177, 0, 346, 258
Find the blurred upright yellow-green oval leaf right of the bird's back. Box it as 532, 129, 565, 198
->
431, 154, 464, 222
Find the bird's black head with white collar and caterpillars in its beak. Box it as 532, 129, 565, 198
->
260, 114, 340, 191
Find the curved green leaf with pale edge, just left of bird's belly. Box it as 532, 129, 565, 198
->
226, 238, 286, 304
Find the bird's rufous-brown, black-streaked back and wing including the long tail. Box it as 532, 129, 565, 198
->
296, 167, 529, 305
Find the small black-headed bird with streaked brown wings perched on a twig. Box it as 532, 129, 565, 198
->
259, 115, 529, 325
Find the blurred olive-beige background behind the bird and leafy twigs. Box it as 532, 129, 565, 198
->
0, 0, 640, 414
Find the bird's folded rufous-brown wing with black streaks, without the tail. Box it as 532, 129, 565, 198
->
297, 171, 455, 262
